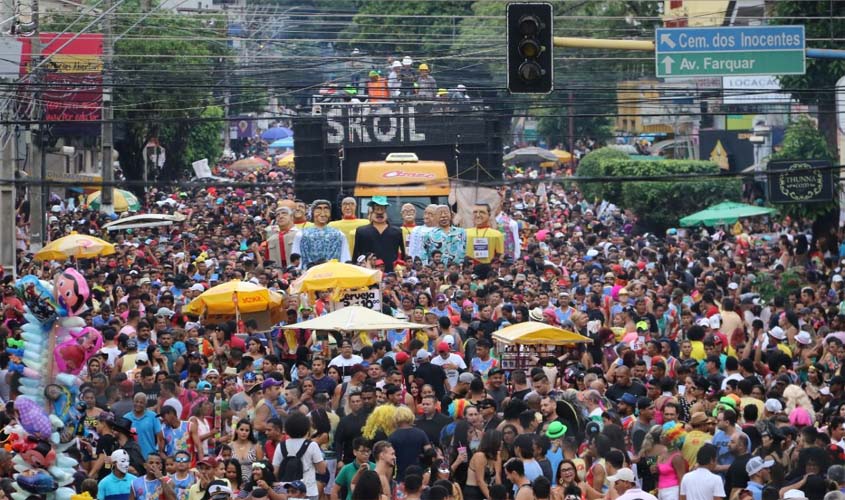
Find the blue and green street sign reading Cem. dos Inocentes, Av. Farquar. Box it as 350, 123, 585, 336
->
654, 26, 806, 78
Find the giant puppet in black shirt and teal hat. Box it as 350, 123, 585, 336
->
352, 196, 405, 273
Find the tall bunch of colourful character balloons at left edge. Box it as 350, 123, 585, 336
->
3, 268, 103, 500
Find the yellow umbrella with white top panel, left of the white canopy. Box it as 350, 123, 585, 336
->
183, 280, 282, 316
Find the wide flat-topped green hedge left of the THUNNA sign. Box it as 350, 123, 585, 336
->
579, 159, 740, 231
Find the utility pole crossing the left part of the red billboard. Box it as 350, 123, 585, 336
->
29, 0, 47, 252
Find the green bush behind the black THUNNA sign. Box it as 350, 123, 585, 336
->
770, 116, 839, 220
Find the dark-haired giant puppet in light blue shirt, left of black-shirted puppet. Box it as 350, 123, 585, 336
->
292, 200, 351, 269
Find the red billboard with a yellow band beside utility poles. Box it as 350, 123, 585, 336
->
19, 33, 103, 122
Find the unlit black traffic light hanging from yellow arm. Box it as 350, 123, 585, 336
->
507, 3, 554, 94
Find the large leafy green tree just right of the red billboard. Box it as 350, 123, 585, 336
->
109, 0, 232, 179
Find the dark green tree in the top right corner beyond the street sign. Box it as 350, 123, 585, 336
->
771, 0, 845, 150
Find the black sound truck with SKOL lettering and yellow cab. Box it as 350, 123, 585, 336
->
293, 100, 506, 223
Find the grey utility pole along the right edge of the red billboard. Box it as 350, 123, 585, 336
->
100, 0, 114, 214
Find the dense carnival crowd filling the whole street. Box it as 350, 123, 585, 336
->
0, 144, 845, 500
